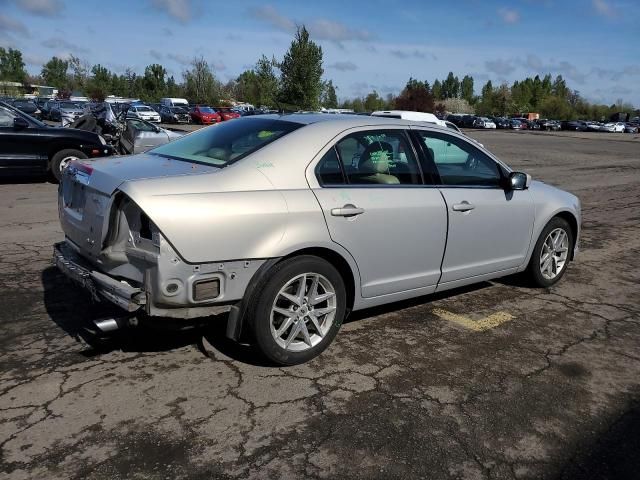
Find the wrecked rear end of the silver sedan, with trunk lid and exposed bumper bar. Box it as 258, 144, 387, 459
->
53, 156, 259, 318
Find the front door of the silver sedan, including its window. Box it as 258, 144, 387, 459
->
418, 130, 535, 284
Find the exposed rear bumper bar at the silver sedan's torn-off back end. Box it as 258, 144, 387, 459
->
53, 242, 146, 312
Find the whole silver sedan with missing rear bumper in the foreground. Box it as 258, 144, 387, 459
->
54, 114, 580, 364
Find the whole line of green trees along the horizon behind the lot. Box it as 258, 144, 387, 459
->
0, 30, 634, 119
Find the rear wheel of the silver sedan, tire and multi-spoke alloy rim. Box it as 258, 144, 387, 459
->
247, 255, 347, 365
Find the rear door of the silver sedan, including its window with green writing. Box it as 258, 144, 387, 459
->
313, 128, 447, 298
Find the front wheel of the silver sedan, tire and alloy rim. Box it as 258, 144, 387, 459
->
527, 217, 574, 288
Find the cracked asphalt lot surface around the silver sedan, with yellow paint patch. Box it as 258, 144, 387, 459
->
0, 131, 640, 480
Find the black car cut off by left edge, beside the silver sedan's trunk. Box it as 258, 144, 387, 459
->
0, 102, 113, 180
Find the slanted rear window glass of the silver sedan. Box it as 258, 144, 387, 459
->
149, 118, 302, 167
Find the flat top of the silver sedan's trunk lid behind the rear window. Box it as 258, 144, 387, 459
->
69, 153, 220, 195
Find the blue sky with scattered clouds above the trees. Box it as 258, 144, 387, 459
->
0, 0, 640, 107
